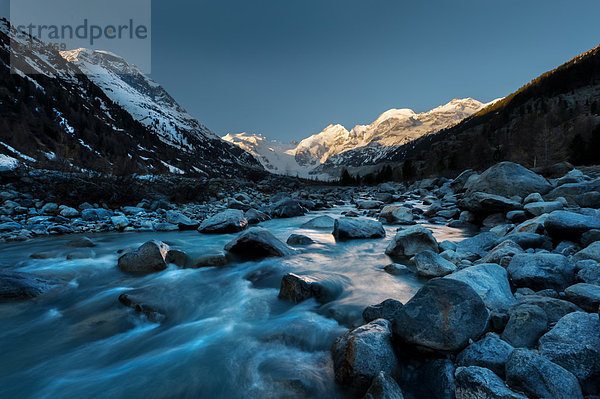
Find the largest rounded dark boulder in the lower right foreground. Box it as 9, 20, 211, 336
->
393, 278, 489, 352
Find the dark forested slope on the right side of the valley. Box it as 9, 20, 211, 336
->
382, 43, 600, 175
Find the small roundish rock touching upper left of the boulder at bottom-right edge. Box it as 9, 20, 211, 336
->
502, 304, 548, 348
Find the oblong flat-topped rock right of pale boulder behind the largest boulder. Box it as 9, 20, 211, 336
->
507, 253, 575, 291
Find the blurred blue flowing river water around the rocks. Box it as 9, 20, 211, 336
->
0, 207, 464, 399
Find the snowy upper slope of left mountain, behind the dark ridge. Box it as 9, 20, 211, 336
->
60, 48, 217, 150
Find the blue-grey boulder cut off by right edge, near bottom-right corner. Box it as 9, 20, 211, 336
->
540, 312, 600, 394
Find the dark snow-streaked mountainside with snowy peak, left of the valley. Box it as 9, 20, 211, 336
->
0, 20, 262, 176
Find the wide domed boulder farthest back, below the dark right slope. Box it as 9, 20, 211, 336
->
467, 162, 552, 198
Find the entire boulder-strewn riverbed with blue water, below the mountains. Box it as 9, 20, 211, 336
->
0, 162, 600, 399
